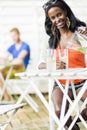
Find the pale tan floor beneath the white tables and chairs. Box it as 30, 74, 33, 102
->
0, 94, 86, 130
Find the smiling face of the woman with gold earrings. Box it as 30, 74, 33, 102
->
48, 7, 67, 29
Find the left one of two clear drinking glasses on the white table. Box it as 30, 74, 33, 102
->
47, 49, 56, 72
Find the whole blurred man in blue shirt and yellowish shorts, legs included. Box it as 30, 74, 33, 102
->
0, 28, 30, 100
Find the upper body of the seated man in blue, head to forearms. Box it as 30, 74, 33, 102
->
7, 28, 30, 68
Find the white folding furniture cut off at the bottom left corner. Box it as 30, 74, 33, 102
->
0, 103, 26, 130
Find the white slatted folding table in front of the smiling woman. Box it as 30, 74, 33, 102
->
16, 68, 87, 130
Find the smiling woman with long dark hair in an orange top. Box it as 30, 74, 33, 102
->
39, 0, 87, 130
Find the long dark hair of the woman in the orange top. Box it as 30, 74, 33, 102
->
43, 0, 86, 49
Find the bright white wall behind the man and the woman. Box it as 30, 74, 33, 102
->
0, 0, 87, 65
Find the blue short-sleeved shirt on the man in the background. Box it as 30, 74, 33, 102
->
8, 42, 30, 68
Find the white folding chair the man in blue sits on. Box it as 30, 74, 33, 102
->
6, 66, 39, 112
